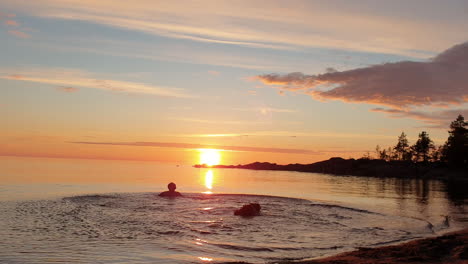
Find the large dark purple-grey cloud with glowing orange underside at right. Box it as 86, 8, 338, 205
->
255, 42, 468, 109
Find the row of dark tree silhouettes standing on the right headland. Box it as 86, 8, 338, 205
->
372, 115, 468, 168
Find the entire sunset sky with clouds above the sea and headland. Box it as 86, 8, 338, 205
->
0, 0, 468, 164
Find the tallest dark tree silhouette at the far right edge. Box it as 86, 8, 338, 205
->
443, 115, 468, 168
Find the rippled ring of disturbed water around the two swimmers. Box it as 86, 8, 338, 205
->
0, 193, 436, 263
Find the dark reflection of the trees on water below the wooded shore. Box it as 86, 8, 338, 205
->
326, 176, 468, 223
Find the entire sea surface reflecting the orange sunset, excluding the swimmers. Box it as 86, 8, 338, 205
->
0, 157, 468, 263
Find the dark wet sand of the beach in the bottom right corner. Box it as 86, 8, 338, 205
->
284, 228, 468, 264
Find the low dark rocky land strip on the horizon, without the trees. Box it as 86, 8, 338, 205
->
194, 157, 468, 180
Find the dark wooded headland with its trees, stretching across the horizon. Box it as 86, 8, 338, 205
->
194, 115, 468, 180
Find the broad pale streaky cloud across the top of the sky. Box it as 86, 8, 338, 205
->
0, 0, 467, 57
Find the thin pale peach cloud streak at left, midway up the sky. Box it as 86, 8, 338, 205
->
0, 69, 193, 98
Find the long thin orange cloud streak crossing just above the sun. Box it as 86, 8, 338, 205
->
70, 141, 322, 155
